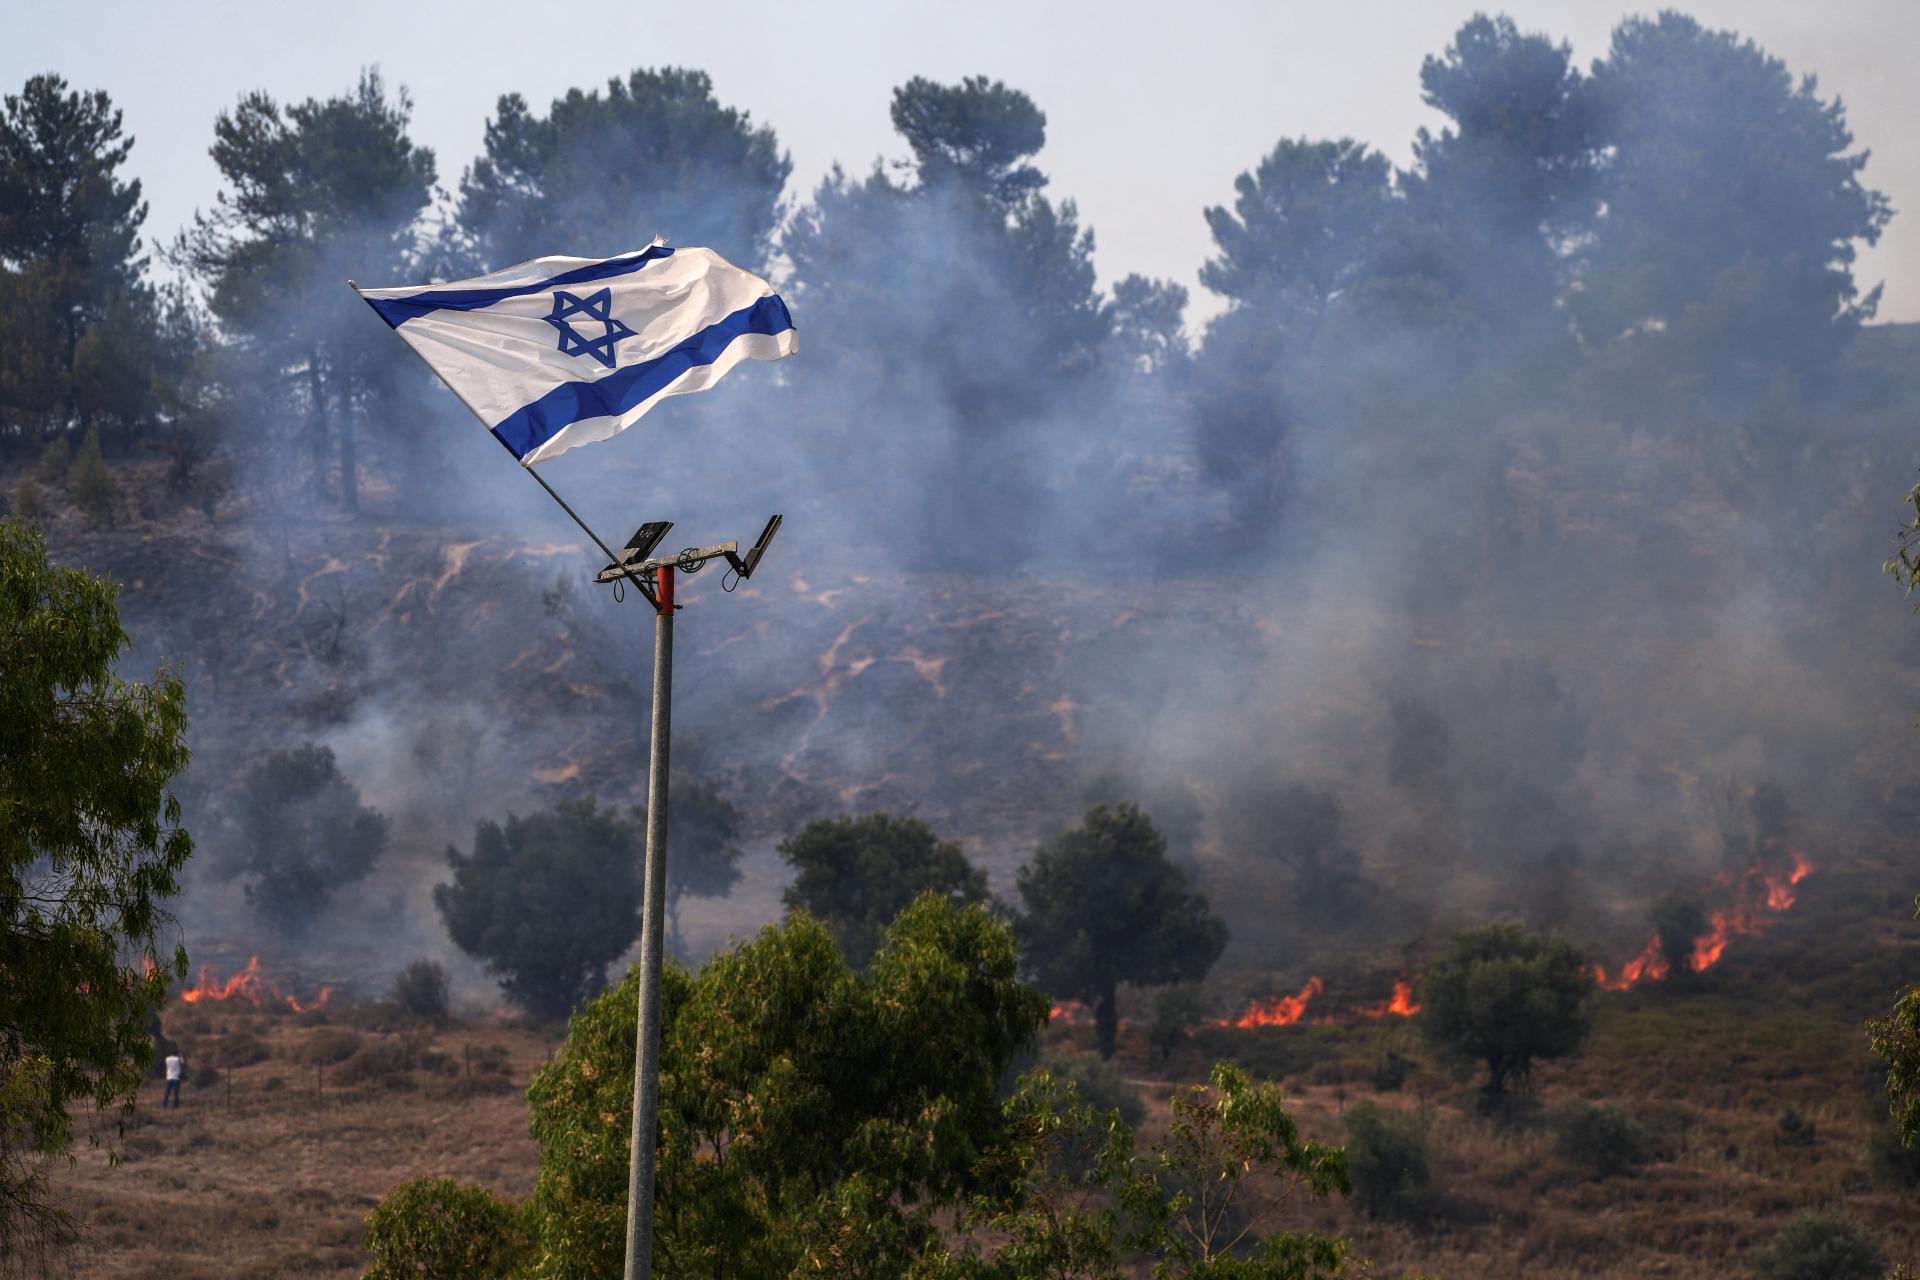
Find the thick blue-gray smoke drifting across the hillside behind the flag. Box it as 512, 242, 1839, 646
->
71, 19, 1916, 1005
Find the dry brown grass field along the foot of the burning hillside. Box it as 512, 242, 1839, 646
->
41, 864, 1920, 1280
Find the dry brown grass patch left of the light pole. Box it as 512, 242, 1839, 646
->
41, 1009, 551, 1280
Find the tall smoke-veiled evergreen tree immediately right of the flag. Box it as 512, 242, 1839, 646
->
781, 77, 1112, 557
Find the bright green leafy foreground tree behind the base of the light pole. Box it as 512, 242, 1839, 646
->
528, 894, 1046, 1278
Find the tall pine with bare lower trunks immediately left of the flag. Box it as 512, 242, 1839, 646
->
175, 71, 434, 510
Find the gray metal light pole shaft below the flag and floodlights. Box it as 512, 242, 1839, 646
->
626, 564, 674, 1280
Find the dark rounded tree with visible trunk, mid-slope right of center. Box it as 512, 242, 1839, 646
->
1016, 804, 1227, 1057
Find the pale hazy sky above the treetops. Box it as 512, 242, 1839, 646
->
15, 0, 1920, 320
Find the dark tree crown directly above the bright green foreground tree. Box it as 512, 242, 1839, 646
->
780, 814, 987, 967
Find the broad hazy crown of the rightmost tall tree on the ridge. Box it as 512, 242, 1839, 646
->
1571, 12, 1891, 372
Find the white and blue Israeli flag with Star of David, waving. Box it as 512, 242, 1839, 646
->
353, 242, 799, 466
